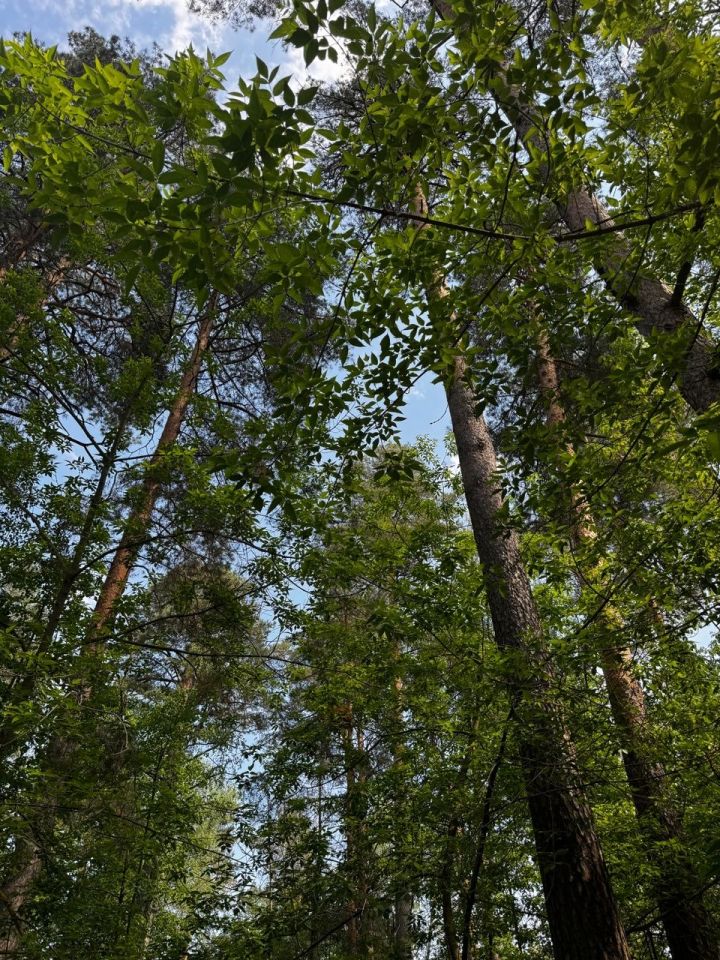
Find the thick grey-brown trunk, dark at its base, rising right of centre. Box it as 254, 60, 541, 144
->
415, 186, 630, 960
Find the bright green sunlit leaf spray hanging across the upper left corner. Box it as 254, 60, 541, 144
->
0, 38, 334, 296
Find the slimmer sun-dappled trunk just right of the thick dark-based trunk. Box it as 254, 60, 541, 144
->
538, 333, 720, 960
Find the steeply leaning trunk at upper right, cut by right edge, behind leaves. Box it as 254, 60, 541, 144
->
432, 0, 720, 412
